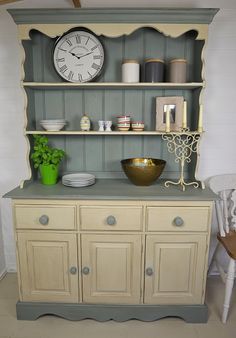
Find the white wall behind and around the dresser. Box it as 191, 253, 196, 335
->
0, 0, 236, 270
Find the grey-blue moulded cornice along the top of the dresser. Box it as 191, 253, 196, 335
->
8, 7, 219, 24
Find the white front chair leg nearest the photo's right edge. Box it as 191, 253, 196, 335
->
222, 258, 235, 323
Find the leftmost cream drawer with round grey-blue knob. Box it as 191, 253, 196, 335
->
15, 204, 76, 230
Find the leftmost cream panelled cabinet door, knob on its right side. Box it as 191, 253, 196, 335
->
18, 232, 78, 303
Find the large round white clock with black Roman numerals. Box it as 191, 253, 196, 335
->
53, 30, 104, 82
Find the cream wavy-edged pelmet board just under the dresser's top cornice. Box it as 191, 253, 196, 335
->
17, 22, 208, 40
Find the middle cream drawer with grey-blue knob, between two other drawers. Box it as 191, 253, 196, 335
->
80, 205, 143, 231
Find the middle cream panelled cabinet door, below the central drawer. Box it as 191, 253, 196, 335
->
81, 234, 141, 304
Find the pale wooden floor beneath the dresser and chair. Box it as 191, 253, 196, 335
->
0, 273, 236, 338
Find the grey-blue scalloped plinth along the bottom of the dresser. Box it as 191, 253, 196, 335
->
16, 302, 208, 323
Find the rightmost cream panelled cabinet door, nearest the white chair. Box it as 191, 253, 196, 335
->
144, 234, 207, 304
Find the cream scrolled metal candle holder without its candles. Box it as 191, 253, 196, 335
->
162, 128, 201, 191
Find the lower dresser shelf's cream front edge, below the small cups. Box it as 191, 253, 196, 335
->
25, 130, 202, 136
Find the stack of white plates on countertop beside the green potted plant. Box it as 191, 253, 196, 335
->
62, 173, 95, 188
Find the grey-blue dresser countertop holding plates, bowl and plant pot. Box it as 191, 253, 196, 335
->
4, 179, 217, 201
